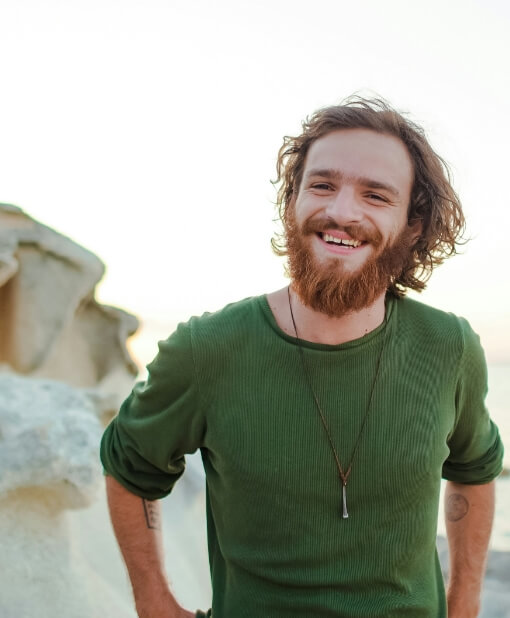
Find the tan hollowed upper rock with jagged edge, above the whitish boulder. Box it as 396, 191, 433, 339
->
0, 204, 138, 414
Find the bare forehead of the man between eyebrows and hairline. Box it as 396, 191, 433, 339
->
304, 129, 414, 194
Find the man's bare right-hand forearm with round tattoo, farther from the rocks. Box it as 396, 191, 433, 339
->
445, 481, 495, 618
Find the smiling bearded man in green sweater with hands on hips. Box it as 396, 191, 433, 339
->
101, 99, 502, 618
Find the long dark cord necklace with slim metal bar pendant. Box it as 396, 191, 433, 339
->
287, 286, 388, 519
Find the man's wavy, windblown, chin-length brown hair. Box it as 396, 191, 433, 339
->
271, 96, 465, 297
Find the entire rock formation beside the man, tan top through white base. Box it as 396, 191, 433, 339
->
0, 204, 138, 618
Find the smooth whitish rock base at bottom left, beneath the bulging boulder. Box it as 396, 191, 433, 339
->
0, 488, 136, 618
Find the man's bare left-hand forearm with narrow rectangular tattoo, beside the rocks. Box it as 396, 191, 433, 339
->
106, 475, 195, 618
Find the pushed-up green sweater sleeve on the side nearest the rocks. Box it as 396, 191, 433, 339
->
101, 324, 205, 500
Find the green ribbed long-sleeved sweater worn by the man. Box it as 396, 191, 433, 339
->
101, 297, 503, 618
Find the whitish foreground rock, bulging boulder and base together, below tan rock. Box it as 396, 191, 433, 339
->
0, 373, 135, 618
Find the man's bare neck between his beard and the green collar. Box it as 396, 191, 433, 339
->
285, 285, 386, 345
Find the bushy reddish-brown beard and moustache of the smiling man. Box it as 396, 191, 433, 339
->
285, 212, 412, 318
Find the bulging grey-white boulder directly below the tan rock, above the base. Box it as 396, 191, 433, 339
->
0, 373, 102, 508
